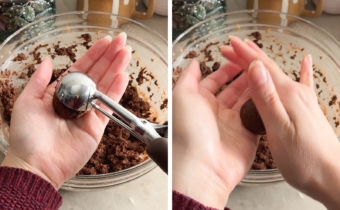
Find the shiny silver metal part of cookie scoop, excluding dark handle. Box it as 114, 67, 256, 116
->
55, 72, 167, 144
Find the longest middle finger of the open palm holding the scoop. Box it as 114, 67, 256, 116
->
87, 32, 127, 83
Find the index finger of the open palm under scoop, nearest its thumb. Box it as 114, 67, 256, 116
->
69, 36, 112, 73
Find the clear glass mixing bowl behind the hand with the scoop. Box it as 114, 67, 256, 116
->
0, 12, 168, 190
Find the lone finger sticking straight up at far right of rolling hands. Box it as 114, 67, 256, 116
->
300, 55, 314, 91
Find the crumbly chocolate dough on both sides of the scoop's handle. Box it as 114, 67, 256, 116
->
78, 81, 151, 175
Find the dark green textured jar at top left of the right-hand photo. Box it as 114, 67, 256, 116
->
172, 0, 227, 40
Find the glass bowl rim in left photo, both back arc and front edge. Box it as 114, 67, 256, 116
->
0, 11, 168, 180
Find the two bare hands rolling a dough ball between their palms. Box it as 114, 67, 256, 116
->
173, 37, 340, 209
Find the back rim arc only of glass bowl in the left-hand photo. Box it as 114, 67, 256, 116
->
0, 11, 168, 50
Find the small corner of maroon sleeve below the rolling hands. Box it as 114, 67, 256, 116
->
172, 190, 229, 210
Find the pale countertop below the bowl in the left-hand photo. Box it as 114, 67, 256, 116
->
59, 167, 168, 210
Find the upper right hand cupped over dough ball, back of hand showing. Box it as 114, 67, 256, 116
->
222, 37, 340, 209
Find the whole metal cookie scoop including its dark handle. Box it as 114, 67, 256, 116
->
55, 72, 168, 173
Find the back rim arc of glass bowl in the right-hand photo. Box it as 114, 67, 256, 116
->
172, 9, 340, 48
